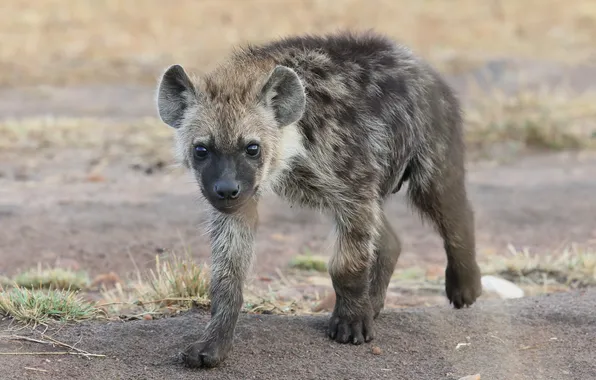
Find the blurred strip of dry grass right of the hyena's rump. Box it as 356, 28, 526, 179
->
466, 88, 596, 150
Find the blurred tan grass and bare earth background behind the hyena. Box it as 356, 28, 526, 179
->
0, 0, 596, 311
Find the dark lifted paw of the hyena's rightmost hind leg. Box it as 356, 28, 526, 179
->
445, 263, 482, 309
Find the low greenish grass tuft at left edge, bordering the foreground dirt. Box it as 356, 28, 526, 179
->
0, 286, 99, 325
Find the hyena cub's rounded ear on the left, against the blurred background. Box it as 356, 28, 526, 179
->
157, 65, 197, 128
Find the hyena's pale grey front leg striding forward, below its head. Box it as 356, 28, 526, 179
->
184, 205, 257, 367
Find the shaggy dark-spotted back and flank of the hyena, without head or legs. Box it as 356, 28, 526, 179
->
206, 33, 461, 206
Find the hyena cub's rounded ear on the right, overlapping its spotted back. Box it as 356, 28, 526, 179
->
259, 66, 306, 127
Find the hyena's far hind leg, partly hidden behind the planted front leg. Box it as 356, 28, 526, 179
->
369, 213, 401, 318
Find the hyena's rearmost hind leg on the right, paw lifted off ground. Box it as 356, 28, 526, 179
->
408, 155, 482, 309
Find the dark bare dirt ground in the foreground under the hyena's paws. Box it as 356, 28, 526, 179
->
0, 289, 596, 380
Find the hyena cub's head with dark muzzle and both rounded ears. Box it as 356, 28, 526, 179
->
157, 65, 306, 213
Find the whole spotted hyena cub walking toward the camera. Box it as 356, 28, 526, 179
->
157, 33, 481, 367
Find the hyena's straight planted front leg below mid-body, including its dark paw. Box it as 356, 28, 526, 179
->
328, 208, 380, 344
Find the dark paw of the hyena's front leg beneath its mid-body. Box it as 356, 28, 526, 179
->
328, 303, 374, 345
